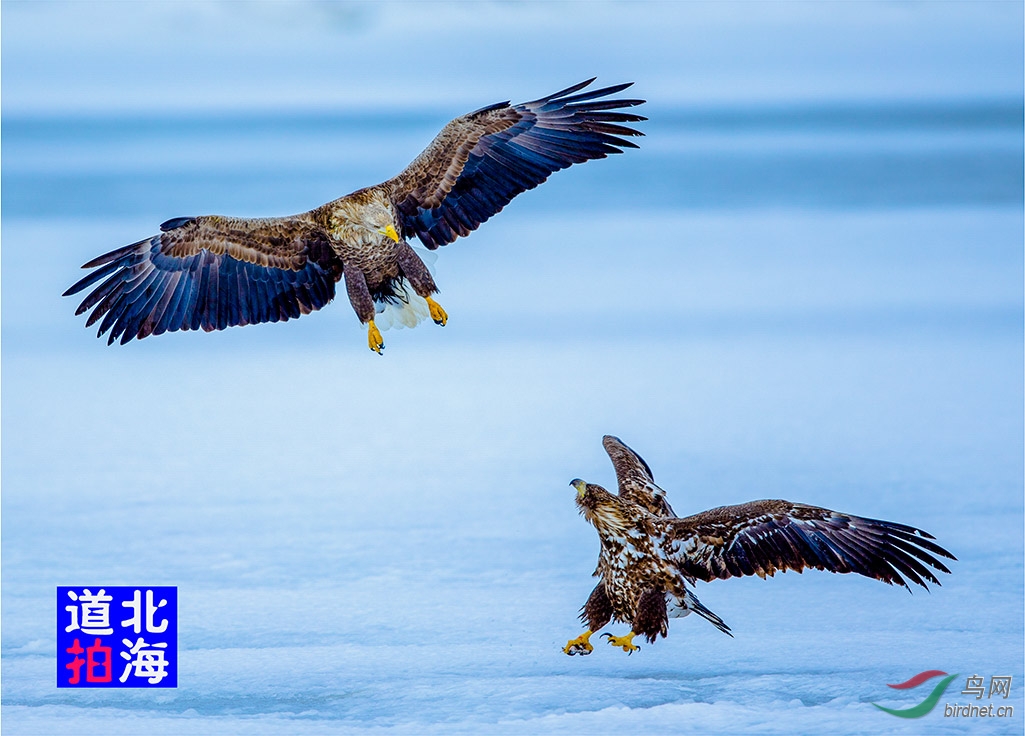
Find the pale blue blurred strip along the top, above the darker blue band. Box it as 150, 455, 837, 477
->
2, 1, 1023, 113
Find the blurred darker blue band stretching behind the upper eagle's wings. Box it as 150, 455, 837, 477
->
2, 99, 1023, 222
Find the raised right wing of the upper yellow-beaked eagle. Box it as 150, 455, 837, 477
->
380, 79, 646, 250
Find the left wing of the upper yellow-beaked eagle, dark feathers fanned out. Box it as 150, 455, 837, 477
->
64, 215, 341, 344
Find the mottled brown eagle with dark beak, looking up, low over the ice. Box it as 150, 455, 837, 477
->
563, 436, 955, 655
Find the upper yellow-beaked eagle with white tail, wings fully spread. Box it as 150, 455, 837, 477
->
65, 79, 646, 354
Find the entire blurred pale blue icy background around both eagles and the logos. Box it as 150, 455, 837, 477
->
2, 2, 1025, 734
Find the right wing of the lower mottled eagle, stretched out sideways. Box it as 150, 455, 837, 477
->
663, 500, 955, 590
